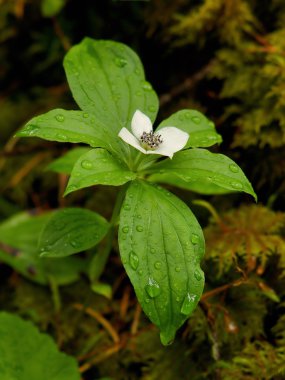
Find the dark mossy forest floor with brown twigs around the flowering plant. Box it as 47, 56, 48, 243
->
0, 0, 285, 380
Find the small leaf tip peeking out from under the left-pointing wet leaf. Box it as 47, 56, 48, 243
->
46, 147, 90, 174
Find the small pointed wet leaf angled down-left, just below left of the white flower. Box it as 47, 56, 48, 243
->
64, 149, 136, 195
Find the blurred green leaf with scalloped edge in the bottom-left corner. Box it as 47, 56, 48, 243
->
0, 312, 80, 380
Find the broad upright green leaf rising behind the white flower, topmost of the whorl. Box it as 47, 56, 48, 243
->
64, 38, 158, 131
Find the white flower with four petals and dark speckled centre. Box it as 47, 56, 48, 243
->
119, 110, 189, 158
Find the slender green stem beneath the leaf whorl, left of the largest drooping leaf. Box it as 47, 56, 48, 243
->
89, 183, 129, 282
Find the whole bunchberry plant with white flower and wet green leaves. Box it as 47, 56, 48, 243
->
18, 38, 256, 344
